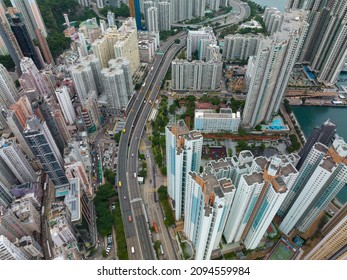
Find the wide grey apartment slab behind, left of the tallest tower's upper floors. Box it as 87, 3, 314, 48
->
223, 34, 262, 60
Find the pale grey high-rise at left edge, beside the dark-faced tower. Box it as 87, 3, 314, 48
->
0, 138, 37, 184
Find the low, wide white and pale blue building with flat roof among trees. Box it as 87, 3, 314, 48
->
194, 108, 241, 132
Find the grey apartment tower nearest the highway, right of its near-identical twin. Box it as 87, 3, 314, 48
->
101, 59, 133, 110
